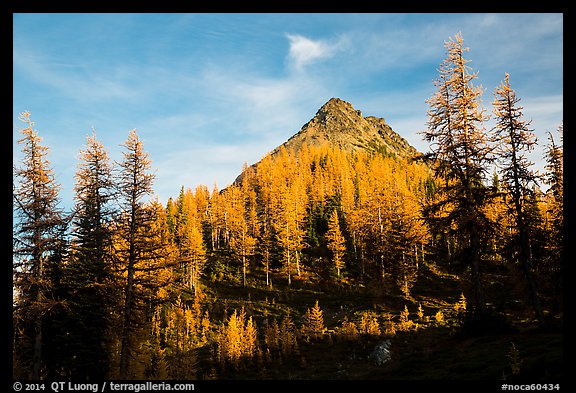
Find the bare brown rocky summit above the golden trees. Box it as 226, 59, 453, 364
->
272, 98, 417, 157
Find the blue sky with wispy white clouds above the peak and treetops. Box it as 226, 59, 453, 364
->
13, 13, 564, 208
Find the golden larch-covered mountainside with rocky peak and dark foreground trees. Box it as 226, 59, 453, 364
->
13, 36, 563, 381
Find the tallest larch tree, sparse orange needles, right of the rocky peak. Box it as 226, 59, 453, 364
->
423, 33, 492, 316
